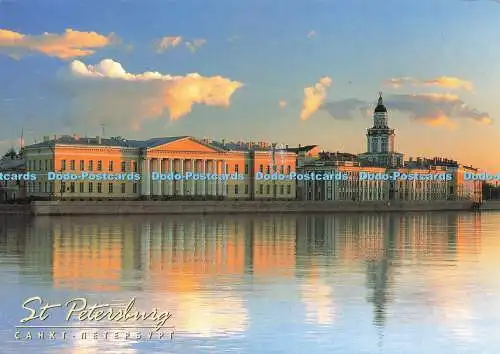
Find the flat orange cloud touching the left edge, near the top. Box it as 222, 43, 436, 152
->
0, 29, 118, 59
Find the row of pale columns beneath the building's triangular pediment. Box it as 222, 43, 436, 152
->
141, 157, 228, 196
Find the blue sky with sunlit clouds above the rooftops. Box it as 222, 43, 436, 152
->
0, 0, 500, 171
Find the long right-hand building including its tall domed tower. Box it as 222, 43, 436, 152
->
297, 92, 482, 202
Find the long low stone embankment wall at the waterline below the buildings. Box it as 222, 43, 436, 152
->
12, 201, 472, 215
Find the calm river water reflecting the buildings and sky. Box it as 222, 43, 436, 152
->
0, 212, 500, 354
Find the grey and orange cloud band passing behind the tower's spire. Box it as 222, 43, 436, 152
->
321, 93, 493, 128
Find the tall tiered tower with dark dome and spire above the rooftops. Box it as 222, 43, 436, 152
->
359, 92, 403, 168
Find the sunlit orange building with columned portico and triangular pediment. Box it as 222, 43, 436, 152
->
25, 136, 296, 199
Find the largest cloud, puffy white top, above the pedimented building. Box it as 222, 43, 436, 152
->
59, 59, 243, 129
